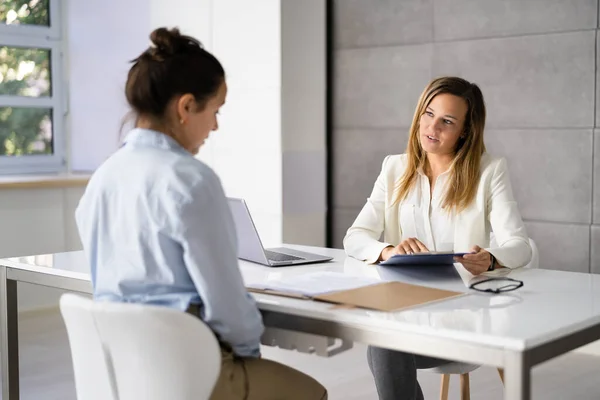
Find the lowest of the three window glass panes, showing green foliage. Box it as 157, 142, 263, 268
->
0, 107, 52, 156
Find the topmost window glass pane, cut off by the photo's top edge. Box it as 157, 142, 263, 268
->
0, 0, 50, 26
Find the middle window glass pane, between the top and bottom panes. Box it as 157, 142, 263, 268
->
0, 46, 51, 97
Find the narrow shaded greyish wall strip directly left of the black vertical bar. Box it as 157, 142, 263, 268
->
281, 0, 327, 246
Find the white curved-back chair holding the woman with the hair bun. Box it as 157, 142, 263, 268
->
60, 294, 221, 400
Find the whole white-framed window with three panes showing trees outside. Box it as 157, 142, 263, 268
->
0, 0, 66, 174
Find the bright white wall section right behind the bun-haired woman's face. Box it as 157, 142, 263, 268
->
151, 0, 283, 243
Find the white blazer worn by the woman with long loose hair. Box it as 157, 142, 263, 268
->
344, 154, 532, 268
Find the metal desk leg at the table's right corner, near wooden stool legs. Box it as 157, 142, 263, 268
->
504, 352, 531, 400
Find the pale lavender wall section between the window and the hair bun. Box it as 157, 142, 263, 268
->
63, 0, 150, 171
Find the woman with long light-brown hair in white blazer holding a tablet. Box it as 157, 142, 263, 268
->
344, 77, 531, 400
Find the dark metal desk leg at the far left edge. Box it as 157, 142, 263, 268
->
0, 266, 19, 400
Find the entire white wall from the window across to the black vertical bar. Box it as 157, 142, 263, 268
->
66, 0, 326, 245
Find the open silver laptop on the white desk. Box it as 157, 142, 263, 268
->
227, 197, 333, 267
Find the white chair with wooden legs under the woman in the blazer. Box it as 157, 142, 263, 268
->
427, 239, 540, 400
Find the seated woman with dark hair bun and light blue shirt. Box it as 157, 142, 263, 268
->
76, 28, 327, 400
